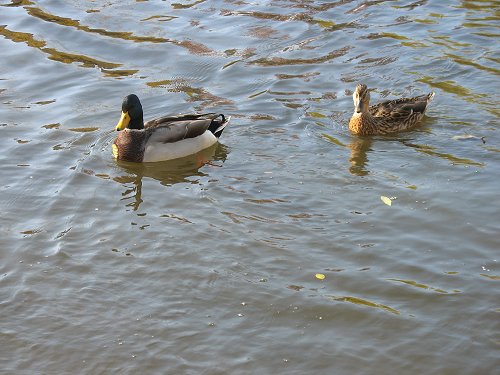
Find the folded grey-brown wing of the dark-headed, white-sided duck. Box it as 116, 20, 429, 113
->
144, 113, 221, 143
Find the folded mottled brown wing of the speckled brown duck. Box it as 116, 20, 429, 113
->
369, 92, 434, 119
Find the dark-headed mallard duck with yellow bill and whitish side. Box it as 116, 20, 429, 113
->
113, 94, 229, 162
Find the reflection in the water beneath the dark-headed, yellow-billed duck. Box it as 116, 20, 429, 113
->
114, 143, 228, 211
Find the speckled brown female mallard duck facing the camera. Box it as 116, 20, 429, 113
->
349, 84, 434, 135
